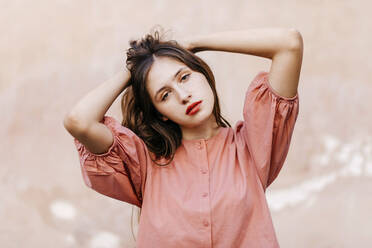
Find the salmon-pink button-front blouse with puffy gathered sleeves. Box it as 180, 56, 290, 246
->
74, 71, 299, 248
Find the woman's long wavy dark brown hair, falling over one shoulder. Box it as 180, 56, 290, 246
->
121, 26, 231, 240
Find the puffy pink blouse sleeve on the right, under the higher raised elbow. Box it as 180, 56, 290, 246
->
241, 71, 299, 190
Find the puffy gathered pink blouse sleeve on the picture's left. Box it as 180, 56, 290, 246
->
74, 116, 149, 207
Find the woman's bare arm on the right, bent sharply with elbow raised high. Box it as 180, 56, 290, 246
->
183, 28, 303, 97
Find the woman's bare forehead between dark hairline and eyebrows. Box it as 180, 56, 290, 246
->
146, 57, 187, 97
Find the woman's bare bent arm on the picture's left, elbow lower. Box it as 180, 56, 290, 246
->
63, 67, 131, 154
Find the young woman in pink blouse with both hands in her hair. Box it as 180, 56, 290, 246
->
64, 28, 303, 248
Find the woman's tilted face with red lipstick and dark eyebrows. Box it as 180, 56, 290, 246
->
146, 57, 214, 128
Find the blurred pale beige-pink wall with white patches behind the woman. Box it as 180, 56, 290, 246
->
0, 0, 372, 248
